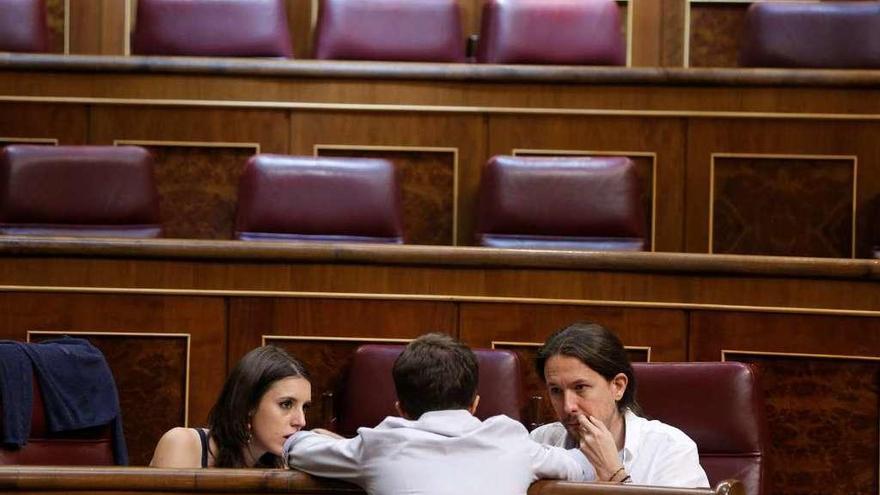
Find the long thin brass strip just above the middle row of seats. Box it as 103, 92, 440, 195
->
8, 95, 880, 121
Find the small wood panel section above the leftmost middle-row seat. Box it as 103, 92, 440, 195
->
0, 102, 89, 144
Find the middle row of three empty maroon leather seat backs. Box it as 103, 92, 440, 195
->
0, 145, 646, 250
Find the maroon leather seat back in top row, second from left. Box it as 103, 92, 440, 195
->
131, 0, 293, 58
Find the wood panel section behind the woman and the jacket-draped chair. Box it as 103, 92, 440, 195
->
0, 293, 226, 463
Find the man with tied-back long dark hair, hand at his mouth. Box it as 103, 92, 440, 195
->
531, 323, 709, 488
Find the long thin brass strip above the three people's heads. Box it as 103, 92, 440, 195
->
0, 285, 880, 317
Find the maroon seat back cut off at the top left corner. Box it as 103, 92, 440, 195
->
0, 0, 49, 52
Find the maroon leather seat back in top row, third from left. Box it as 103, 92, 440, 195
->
315, 0, 465, 62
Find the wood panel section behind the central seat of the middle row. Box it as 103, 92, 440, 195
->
290, 112, 486, 244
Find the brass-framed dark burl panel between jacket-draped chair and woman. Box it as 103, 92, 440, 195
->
31, 332, 189, 466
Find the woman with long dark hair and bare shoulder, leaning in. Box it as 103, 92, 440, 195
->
150, 346, 312, 468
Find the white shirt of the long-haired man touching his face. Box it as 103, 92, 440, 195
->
531, 409, 709, 488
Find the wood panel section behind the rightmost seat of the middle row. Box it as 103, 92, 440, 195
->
489, 115, 685, 251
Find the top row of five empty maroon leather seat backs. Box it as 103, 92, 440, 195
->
0, 0, 880, 68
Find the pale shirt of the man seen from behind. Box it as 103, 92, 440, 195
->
284, 409, 584, 495
